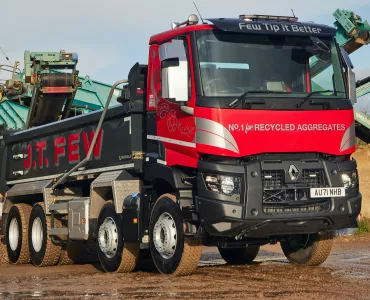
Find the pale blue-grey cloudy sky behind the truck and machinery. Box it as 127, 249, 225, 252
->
0, 0, 370, 109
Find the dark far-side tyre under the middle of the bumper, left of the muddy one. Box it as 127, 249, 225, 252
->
218, 245, 260, 265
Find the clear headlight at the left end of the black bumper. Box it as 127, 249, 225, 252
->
204, 175, 240, 196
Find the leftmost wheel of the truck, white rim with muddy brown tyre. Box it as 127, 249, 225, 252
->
5, 203, 31, 265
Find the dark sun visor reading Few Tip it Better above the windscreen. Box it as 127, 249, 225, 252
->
206, 18, 336, 37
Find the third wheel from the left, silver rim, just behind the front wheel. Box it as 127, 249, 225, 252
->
97, 202, 140, 273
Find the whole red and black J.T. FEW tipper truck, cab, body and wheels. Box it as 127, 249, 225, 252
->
0, 15, 361, 275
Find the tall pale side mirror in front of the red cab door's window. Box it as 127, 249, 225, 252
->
159, 38, 191, 102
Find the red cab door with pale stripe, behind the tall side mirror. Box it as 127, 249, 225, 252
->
147, 35, 198, 167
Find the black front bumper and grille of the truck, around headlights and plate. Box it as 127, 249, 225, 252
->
195, 160, 362, 238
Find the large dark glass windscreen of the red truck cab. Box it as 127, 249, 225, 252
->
197, 31, 346, 99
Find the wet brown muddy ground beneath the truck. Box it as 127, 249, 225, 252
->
0, 236, 370, 300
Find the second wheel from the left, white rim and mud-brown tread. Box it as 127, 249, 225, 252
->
28, 203, 61, 267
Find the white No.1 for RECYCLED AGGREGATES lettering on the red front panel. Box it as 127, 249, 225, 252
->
228, 123, 346, 133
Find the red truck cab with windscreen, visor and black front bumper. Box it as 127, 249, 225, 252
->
139, 15, 361, 272
